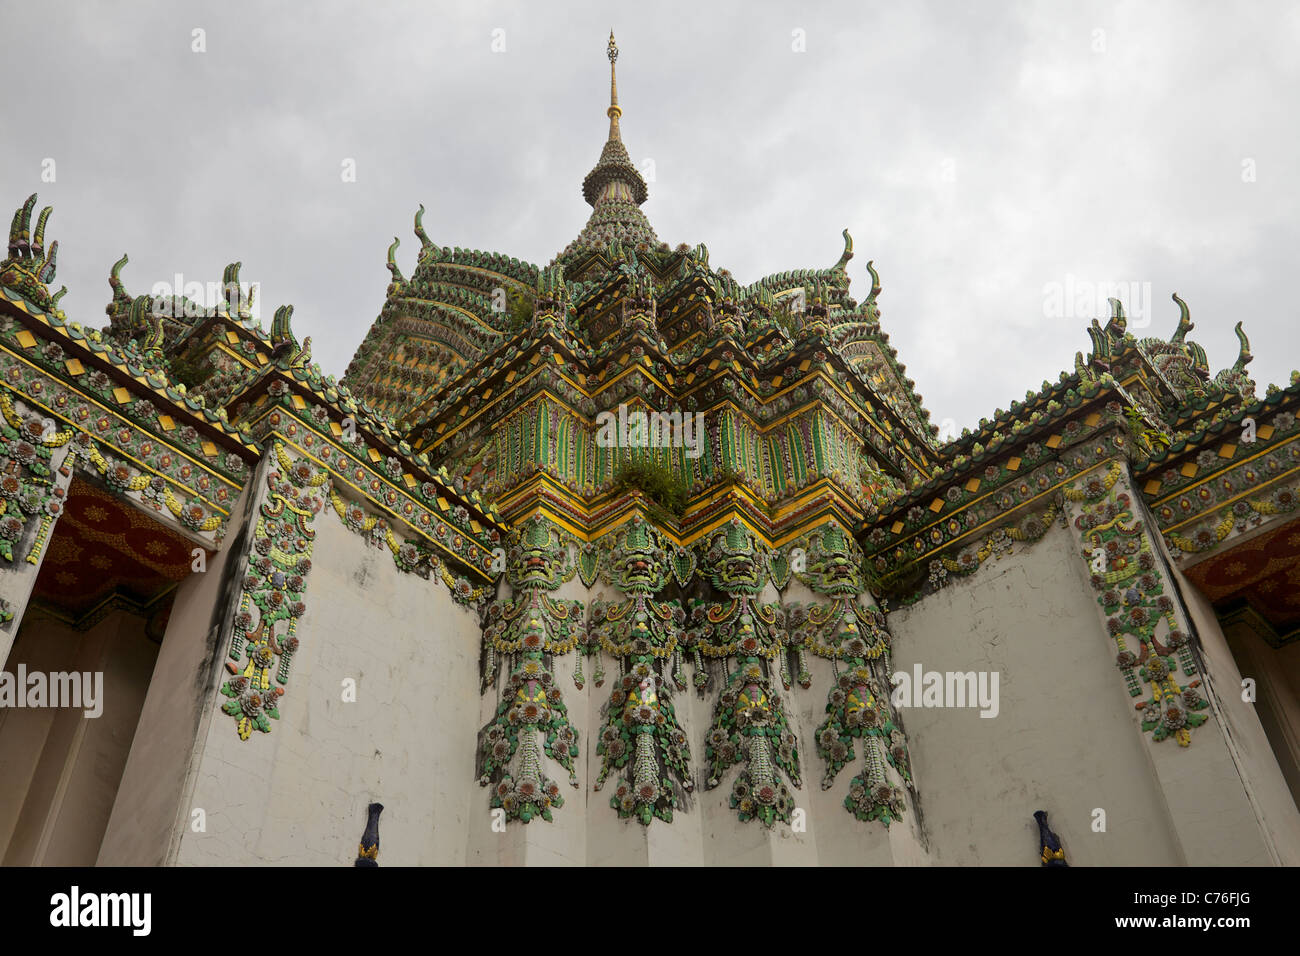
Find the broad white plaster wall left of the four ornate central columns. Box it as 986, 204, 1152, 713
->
167, 507, 480, 866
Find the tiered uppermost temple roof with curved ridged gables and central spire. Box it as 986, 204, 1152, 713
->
345, 33, 937, 446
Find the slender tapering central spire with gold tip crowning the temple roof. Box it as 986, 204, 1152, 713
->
555, 30, 659, 264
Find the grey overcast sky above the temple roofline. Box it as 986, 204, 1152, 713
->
0, 0, 1300, 437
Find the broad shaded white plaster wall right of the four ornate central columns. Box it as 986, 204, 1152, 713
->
888, 525, 1185, 866
